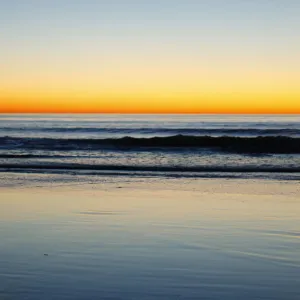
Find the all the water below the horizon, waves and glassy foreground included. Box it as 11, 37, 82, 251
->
0, 114, 300, 300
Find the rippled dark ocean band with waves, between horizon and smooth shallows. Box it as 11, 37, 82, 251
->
0, 114, 300, 179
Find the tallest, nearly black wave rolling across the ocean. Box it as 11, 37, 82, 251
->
0, 135, 300, 154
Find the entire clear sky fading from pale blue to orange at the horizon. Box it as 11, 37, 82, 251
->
0, 0, 300, 113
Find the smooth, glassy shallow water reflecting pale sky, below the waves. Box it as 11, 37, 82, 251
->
0, 173, 300, 300
